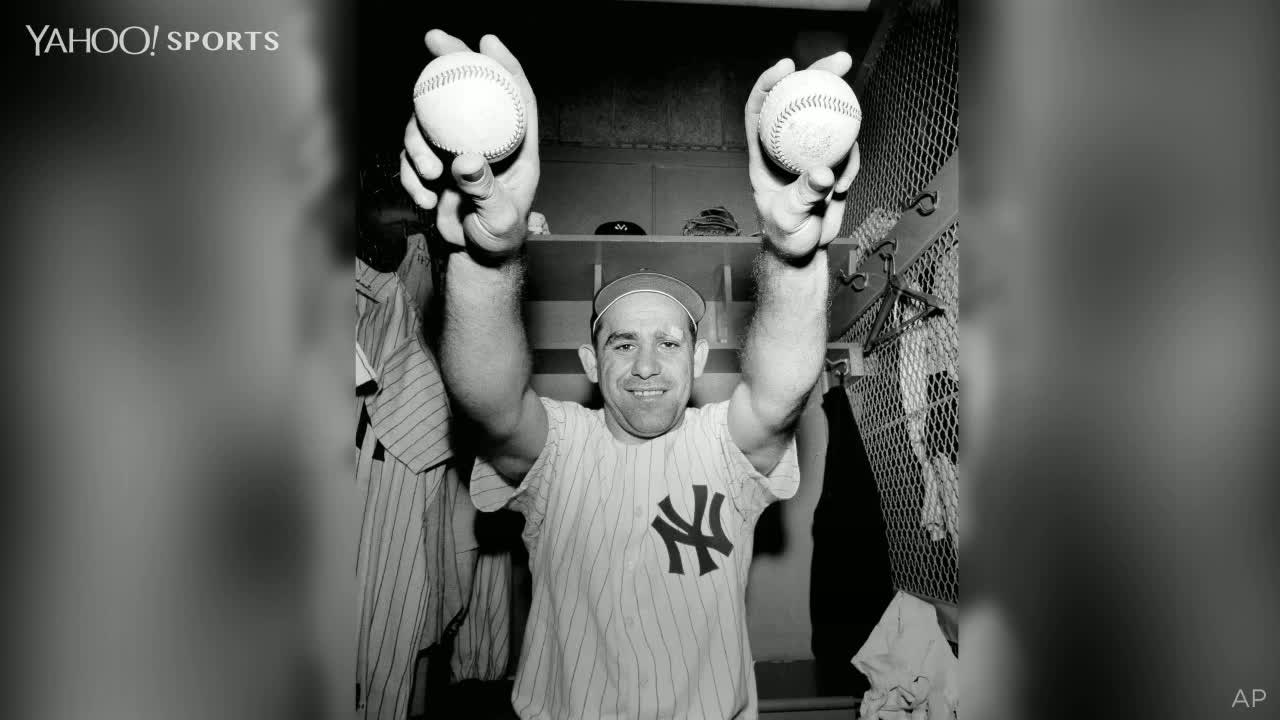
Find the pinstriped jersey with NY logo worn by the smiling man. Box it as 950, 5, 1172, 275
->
471, 397, 799, 720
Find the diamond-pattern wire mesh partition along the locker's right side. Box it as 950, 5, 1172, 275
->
842, 1, 960, 603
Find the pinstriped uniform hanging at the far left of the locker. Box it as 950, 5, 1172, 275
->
356, 260, 461, 719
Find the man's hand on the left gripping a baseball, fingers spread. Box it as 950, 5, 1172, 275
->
399, 29, 539, 259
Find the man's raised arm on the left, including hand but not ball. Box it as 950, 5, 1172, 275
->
401, 29, 547, 483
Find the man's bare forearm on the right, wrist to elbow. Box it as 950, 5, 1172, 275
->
742, 249, 831, 432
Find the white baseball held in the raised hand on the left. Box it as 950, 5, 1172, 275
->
413, 53, 526, 163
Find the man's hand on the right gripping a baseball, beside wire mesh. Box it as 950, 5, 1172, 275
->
746, 53, 859, 261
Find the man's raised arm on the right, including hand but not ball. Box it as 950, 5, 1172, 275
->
728, 53, 859, 473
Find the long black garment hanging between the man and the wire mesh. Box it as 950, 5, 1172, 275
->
809, 386, 893, 692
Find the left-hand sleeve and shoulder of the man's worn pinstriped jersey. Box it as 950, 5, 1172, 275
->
471, 397, 568, 534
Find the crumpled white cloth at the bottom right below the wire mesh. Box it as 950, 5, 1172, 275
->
852, 592, 960, 720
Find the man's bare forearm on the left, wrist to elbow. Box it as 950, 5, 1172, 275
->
440, 245, 531, 439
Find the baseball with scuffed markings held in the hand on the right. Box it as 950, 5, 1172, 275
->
760, 70, 863, 174
